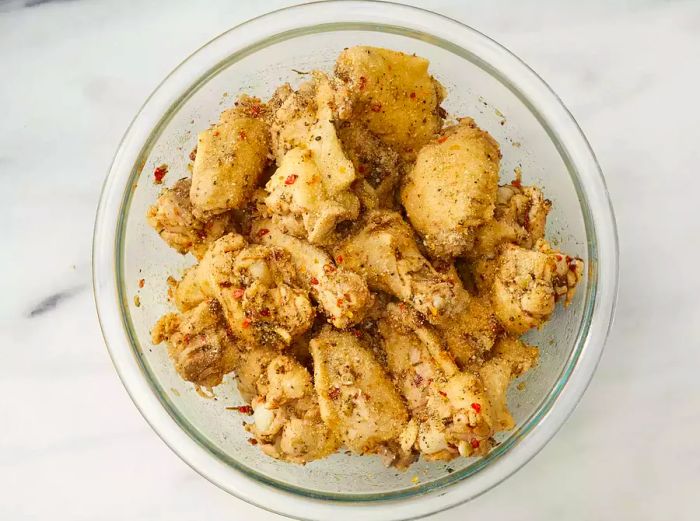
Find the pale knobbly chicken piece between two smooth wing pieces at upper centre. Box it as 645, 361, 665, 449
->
265, 73, 360, 244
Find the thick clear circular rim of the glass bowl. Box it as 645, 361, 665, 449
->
93, 0, 618, 520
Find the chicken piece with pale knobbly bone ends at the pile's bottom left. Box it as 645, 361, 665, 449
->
246, 355, 340, 464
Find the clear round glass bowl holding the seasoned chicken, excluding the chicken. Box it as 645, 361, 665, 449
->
93, 1, 617, 521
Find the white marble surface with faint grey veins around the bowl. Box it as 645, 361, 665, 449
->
0, 0, 700, 521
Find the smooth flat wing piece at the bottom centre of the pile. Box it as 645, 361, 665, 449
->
310, 327, 408, 454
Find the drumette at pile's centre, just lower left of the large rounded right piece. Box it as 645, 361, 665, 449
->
336, 210, 454, 319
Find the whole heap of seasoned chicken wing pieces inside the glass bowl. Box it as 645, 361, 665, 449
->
145, 46, 583, 468
